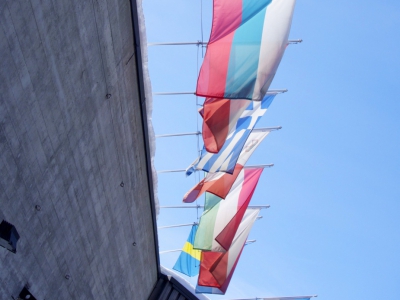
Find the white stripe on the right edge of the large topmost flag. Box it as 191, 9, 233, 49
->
253, 0, 296, 100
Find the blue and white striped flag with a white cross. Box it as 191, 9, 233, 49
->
186, 95, 275, 176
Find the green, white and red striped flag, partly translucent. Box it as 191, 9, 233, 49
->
193, 168, 263, 252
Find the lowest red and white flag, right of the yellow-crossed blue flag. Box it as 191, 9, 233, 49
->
196, 208, 260, 294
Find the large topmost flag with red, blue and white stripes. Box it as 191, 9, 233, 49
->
196, 0, 295, 100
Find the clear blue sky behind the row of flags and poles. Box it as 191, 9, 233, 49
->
143, 0, 400, 300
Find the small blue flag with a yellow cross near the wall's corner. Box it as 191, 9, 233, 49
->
173, 225, 201, 277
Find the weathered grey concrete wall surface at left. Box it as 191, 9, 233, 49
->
0, 0, 158, 299
